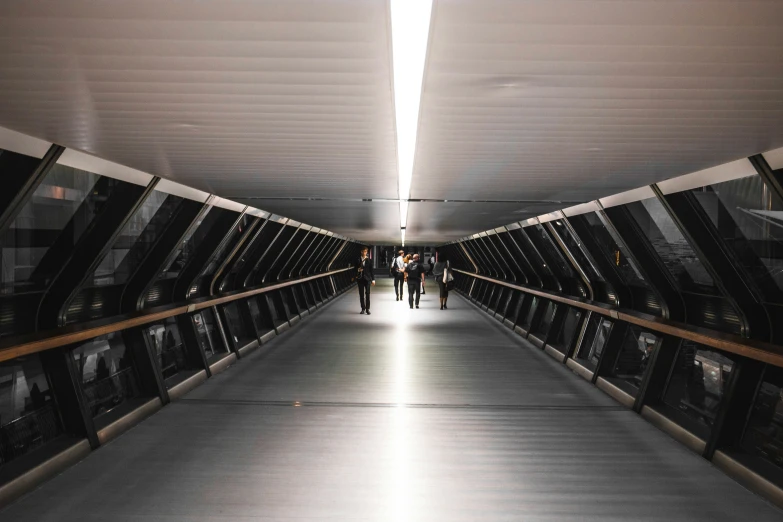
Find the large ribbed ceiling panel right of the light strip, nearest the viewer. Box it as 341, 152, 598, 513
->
411, 0, 783, 204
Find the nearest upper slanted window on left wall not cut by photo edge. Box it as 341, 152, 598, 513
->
92, 191, 177, 286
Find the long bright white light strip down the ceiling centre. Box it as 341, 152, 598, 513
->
391, 0, 432, 243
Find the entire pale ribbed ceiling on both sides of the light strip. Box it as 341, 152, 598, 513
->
0, 0, 783, 243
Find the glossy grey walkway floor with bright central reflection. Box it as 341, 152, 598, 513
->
0, 281, 783, 522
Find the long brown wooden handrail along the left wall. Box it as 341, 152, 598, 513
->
0, 267, 351, 362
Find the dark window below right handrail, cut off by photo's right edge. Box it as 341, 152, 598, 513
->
742, 366, 783, 468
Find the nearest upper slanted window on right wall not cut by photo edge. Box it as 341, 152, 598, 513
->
628, 198, 718, 295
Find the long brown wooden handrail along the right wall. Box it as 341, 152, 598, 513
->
454, 268, 783, 367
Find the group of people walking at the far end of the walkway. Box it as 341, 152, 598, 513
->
356, 248, 453, 315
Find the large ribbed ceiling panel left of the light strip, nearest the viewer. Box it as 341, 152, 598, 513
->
0, 0, 397, 203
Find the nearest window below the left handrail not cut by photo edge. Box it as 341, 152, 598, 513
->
71, 333, 140, 417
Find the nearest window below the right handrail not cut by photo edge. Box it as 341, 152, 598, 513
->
663, 341, 734, 427
